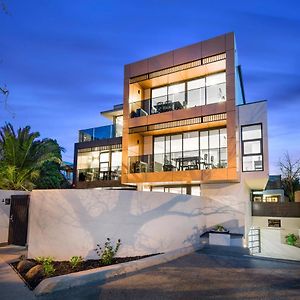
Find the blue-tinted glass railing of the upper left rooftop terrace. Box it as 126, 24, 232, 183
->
79, 125, 116, 142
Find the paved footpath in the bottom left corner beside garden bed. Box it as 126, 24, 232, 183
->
0, 246, 36, 300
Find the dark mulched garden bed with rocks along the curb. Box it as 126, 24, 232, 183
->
11, 253, 160, 290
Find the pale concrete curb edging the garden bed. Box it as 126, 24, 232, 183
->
34, 246, 202, 296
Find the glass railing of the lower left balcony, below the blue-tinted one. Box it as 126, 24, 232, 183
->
77, 167, 121, 182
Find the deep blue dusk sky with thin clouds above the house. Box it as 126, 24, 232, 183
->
0, 0, 300, 174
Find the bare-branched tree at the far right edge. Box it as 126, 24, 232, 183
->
279, 152, 300, 202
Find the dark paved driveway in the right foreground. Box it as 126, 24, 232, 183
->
98, 248, 300, 300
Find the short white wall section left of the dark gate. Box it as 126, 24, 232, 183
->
0, 190, 28, 243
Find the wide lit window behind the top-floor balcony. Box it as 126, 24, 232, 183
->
151, 72, 226, 113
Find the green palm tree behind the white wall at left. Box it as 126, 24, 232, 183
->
0, 123, 62, 190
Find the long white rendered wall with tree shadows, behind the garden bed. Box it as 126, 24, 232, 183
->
28, 187, 244, 260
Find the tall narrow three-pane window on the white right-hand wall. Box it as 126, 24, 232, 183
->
242, 124, 263, 172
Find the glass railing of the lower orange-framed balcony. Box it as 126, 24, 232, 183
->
129, 148, 227, 173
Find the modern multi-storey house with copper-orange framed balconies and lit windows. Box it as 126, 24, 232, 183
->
74, 33, 268, 232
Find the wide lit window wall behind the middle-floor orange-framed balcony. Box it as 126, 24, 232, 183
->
154, 128, 227, 172
